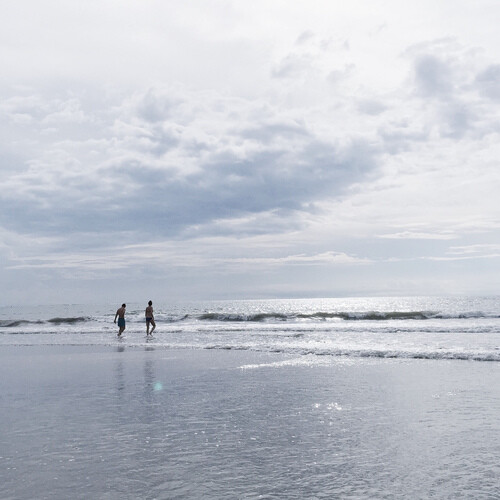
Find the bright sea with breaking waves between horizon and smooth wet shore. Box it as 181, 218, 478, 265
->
0, 297, 500, 362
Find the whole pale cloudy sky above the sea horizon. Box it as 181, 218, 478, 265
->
0, 0, 500, 305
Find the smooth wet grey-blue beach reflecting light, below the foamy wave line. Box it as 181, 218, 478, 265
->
0, 340, 500, 500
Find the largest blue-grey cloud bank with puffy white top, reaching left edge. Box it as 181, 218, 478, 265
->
0, 90, 377, 248
